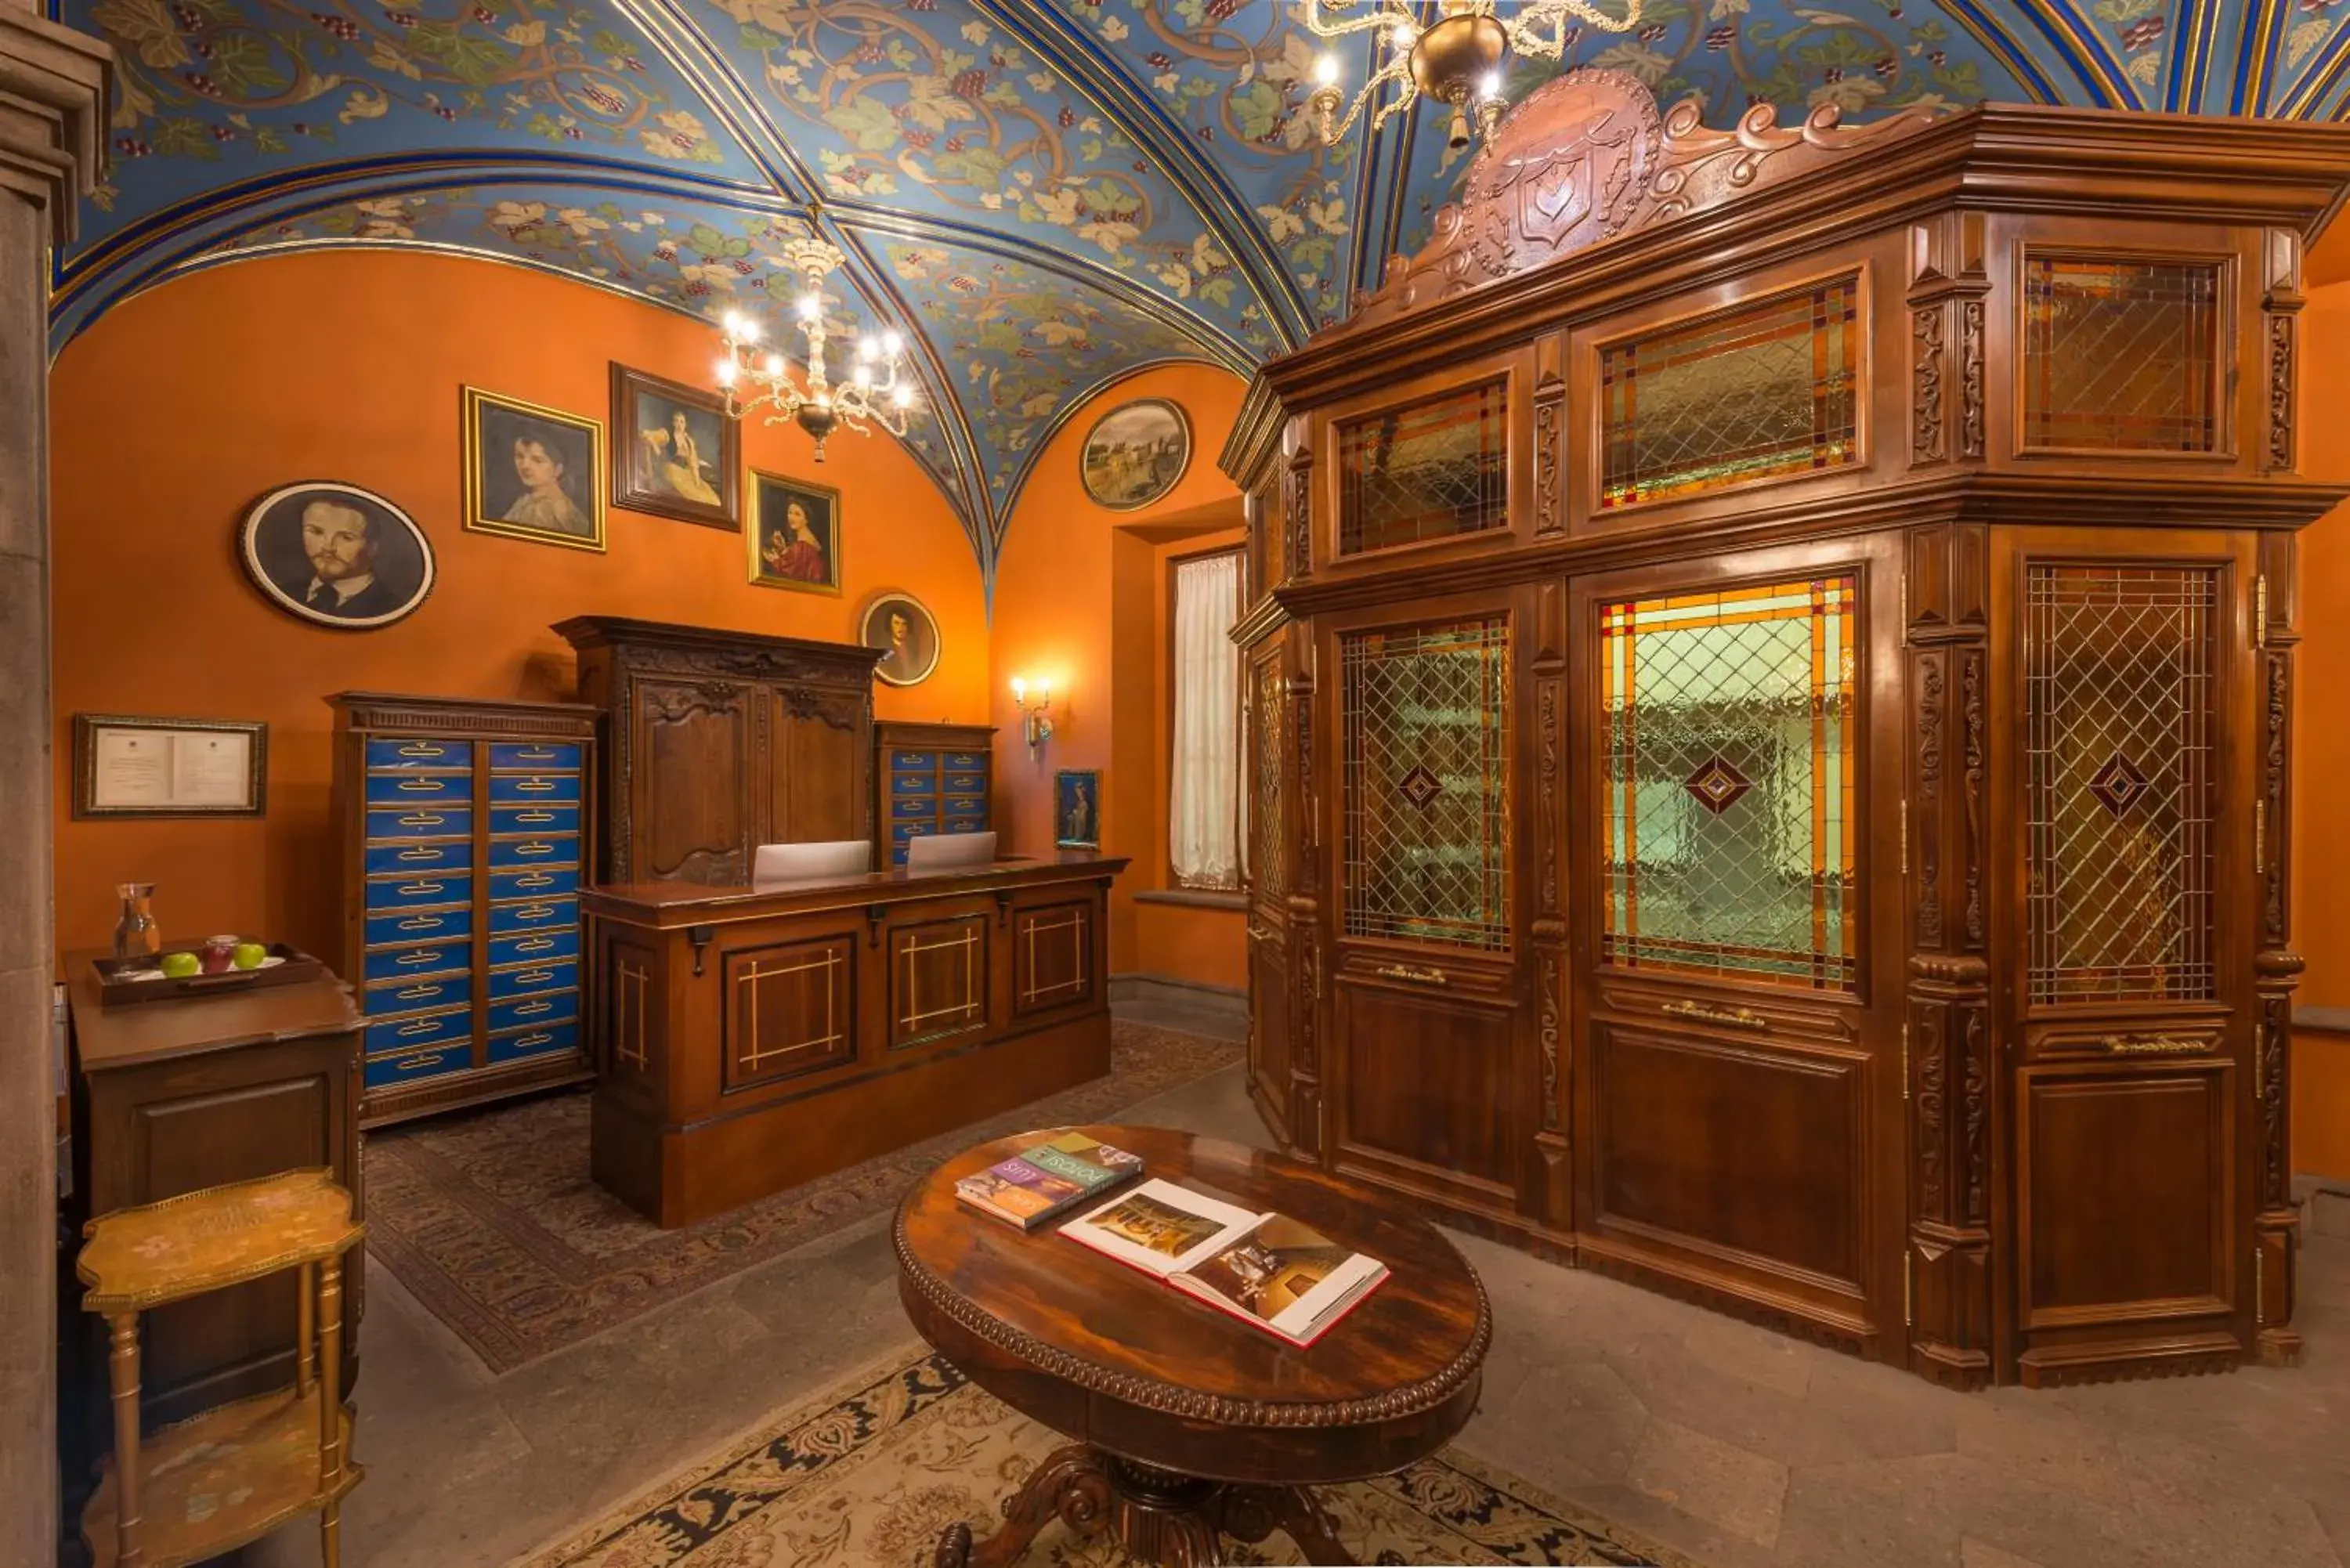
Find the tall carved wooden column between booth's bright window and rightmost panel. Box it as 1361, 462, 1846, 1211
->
1901, 524, 1998, 1389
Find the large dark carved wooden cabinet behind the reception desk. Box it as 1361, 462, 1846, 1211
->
555, 616, 881, 884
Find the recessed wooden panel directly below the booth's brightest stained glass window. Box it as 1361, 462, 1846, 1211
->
1589, 1023, 1868, 1288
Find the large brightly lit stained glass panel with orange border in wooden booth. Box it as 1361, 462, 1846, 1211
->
1600, 576, 1859, 992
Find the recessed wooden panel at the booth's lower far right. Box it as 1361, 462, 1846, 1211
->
2016, 1065, 2237, 1331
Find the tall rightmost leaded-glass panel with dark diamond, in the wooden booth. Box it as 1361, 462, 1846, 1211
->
2023, 564, 2218, 1004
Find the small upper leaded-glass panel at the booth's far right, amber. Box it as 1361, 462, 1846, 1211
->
2023, 256, 2218, 451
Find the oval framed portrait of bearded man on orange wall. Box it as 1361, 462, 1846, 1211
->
237, 479, 435, 632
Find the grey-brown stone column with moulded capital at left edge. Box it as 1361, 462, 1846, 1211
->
0, 0, 113, 1563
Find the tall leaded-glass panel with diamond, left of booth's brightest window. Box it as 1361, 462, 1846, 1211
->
1340, 616, 1509, 948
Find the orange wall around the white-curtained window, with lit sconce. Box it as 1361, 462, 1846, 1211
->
989, 364, 1248, 985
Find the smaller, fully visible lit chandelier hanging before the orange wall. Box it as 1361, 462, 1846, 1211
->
717, 235, 914, 463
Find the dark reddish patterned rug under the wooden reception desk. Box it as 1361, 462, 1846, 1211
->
367, 1023, 1241, 1373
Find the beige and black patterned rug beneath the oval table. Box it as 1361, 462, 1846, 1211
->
526, 1349, 1694, 1568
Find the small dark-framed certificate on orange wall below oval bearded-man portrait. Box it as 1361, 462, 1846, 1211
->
73, 712, 270, 816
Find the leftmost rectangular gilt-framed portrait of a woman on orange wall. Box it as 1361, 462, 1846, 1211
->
463, 385, 604, 550
